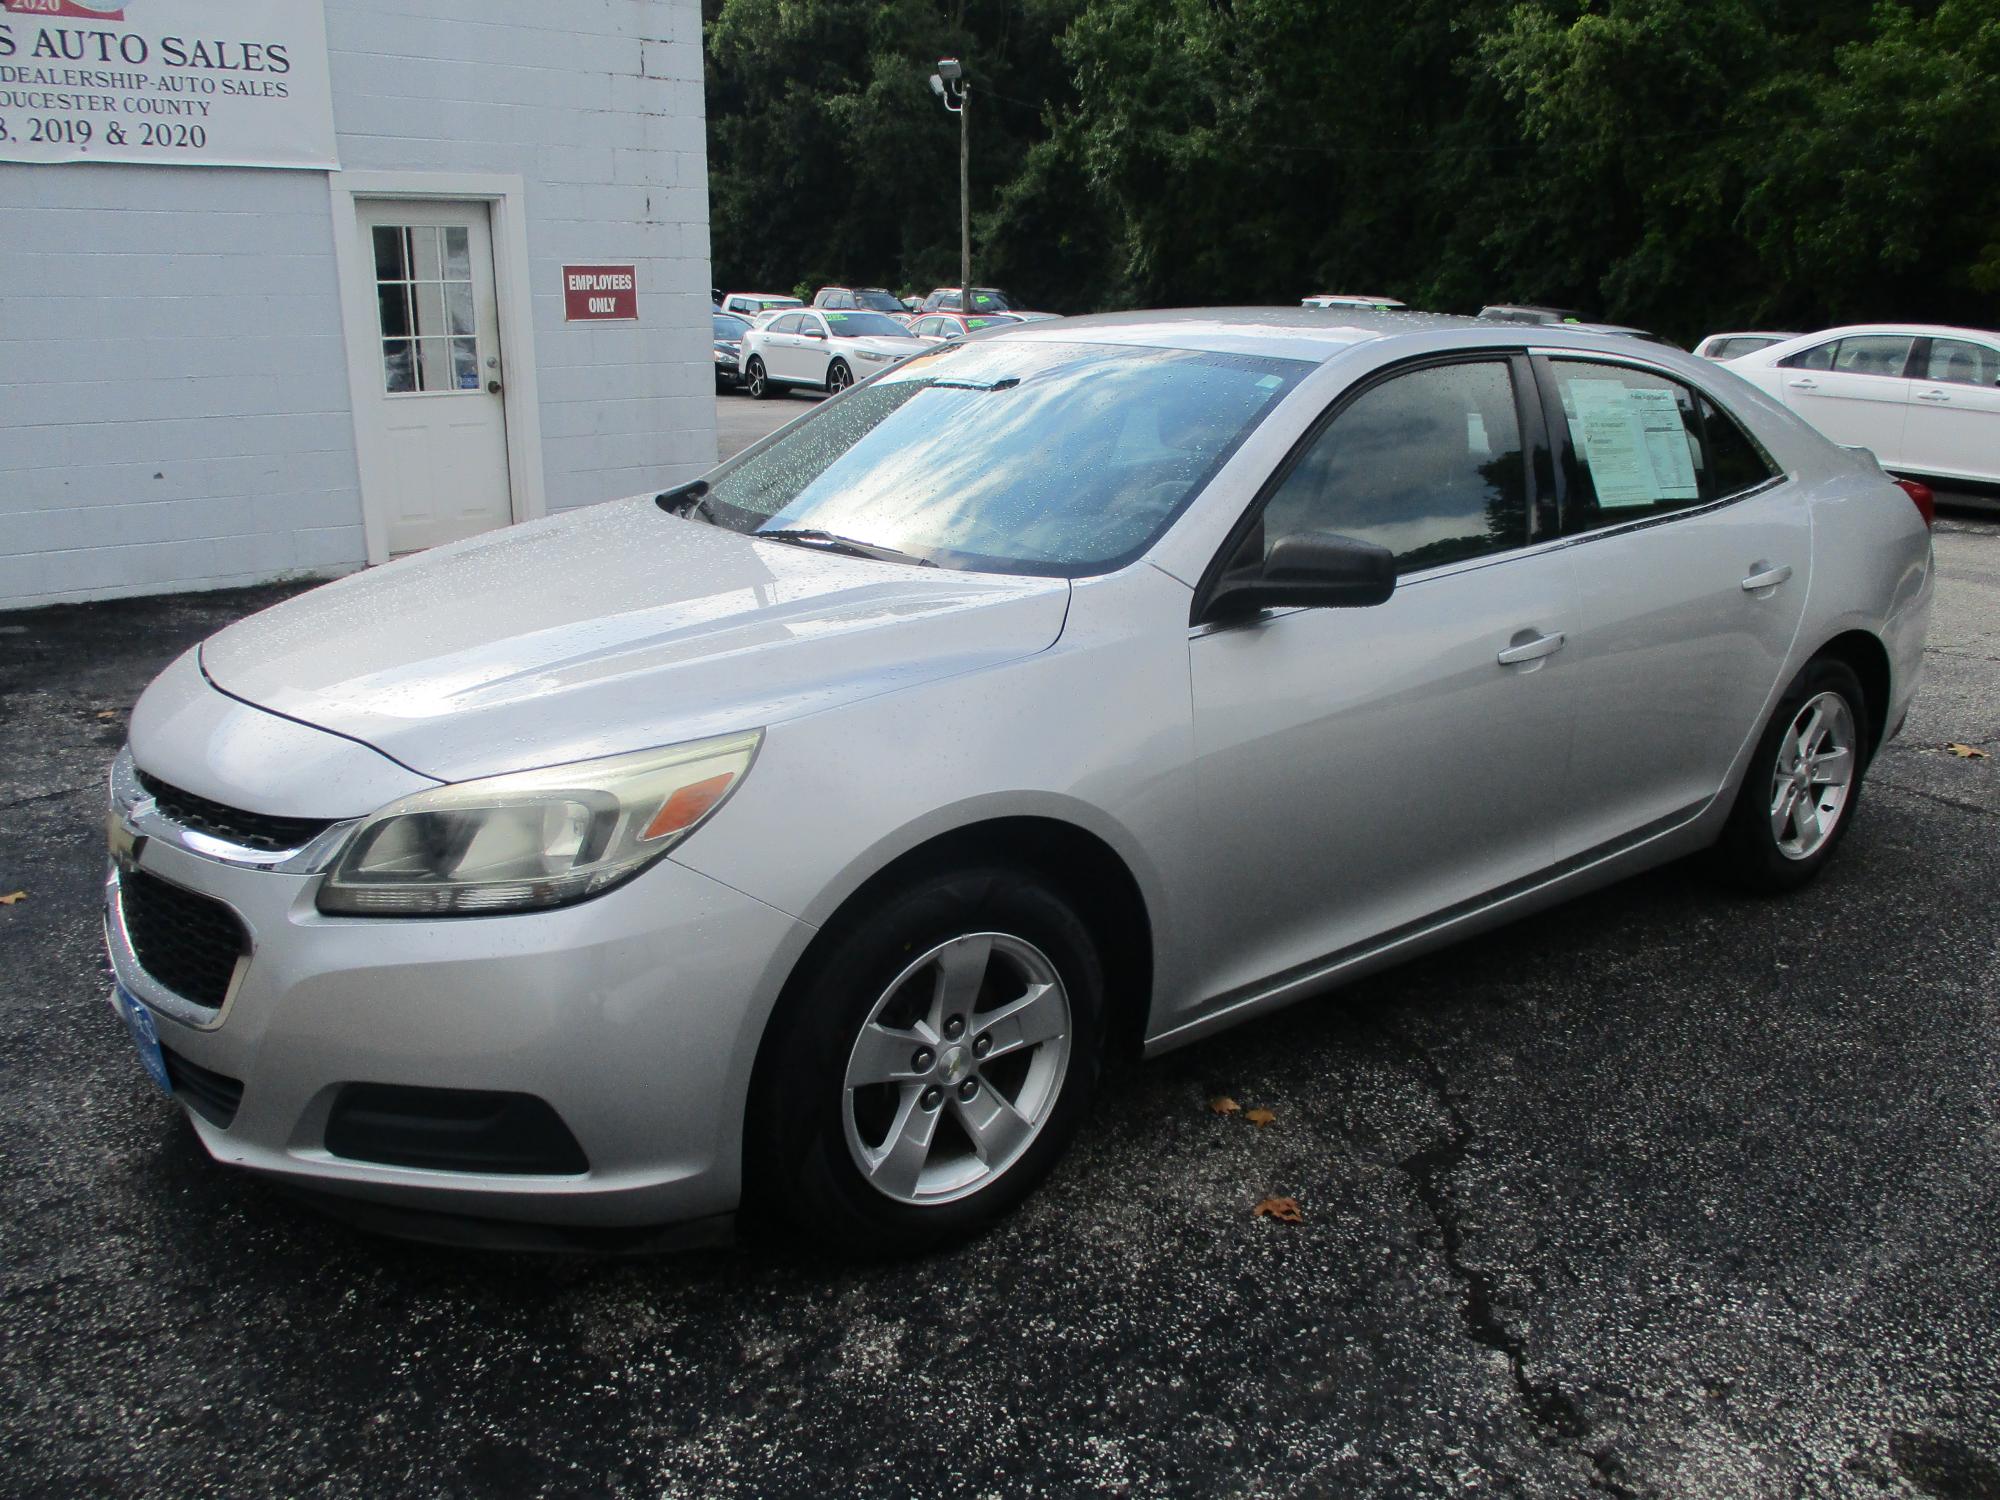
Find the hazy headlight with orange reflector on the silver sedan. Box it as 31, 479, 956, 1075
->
320, 730, 764, 916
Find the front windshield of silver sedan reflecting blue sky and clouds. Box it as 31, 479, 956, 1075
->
700, 340, 1312, 578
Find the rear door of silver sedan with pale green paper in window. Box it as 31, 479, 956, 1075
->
1536, 354, 1812, 846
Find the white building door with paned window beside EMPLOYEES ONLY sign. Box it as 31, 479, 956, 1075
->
354, 198, 514, 554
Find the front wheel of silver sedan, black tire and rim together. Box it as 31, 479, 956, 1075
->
744, 866, 1104, 1258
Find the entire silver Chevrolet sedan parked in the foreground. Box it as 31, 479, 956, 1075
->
106, 310, 1932, 1252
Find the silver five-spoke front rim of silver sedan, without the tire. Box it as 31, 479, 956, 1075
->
842, 932, 1074, 1204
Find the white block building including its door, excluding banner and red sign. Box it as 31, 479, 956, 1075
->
0, 0, 716, 608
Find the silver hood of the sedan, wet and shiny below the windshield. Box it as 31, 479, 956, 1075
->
202, 506, 1070, 780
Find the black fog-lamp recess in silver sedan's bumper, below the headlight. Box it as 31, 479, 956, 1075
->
326, 1084, 590, 1176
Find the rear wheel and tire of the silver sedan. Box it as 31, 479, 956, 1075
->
1712, 656, 1874, 892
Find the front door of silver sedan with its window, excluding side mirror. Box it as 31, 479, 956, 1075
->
1188, 354, 1576, 1008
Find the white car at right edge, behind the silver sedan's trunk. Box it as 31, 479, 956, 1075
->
1730, 322, 2000, 484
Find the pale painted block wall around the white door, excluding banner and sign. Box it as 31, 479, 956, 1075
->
0, 0, 716, 608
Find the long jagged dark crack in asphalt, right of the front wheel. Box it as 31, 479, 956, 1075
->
1374, 1018, 1642, 1500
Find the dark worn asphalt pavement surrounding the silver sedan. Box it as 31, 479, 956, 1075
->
0, 476, 2000, 1500
